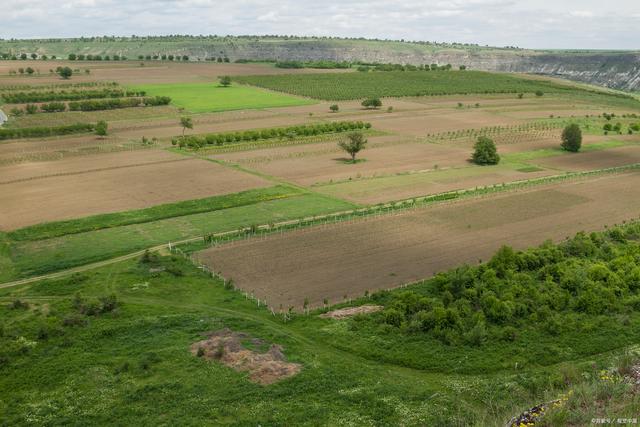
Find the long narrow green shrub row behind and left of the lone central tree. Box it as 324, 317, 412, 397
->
172, 121, 371, 149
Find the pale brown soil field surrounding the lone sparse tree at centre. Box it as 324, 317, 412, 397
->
214, 137, 471, 185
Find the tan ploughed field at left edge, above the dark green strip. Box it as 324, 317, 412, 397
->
0, 157, 269, 231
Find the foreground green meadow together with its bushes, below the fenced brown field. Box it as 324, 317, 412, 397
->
0, 225, 640, 427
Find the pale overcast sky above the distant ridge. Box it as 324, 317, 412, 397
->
5, 0, 640, 49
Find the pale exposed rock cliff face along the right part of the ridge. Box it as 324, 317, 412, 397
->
221, 42, 640, 91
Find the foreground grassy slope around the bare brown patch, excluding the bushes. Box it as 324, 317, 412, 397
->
0, 227, 637, 426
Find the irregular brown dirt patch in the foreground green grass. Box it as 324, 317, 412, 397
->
191, 328, 302, 385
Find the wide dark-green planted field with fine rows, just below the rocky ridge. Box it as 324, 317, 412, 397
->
234, 71, 576, 101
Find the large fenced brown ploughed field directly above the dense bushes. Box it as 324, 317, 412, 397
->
196, 173, 640, 309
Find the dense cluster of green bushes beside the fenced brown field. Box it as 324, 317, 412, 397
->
374, 224, 640, 345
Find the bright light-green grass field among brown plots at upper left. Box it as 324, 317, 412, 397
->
130, 82, 314, 113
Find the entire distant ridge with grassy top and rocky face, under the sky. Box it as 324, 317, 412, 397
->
5, 36, 640, 91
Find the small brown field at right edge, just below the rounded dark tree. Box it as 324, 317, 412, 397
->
535, 145, 640, 171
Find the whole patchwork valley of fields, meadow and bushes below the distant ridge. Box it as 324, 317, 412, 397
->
0, 57, 640, 427
